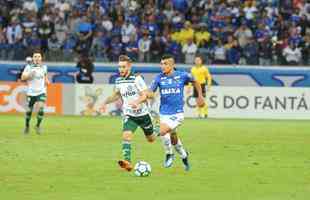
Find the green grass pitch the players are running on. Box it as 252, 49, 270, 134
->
0, 115, 310, 200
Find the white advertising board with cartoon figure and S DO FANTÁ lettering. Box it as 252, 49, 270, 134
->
75, 85, 310, 119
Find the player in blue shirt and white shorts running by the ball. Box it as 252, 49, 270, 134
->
148, 55, 204, 171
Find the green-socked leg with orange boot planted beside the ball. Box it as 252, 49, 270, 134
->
118, 116, 138, 171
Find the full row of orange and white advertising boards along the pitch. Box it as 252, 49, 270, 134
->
0, 82, 310, 119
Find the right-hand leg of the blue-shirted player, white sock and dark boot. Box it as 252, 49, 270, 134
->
170, 130, 190, 171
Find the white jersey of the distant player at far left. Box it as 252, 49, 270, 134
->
23, 64, 47, 96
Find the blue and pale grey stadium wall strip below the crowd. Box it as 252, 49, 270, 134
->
0, 62, 310, 87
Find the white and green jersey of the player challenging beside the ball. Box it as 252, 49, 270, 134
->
115, 73, 149, 117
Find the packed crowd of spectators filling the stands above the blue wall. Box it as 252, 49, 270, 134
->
0, 0, 310, 66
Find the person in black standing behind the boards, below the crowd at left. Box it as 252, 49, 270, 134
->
76, 53, 94, 83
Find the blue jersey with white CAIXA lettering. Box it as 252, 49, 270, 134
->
151, 71, 194, 115
